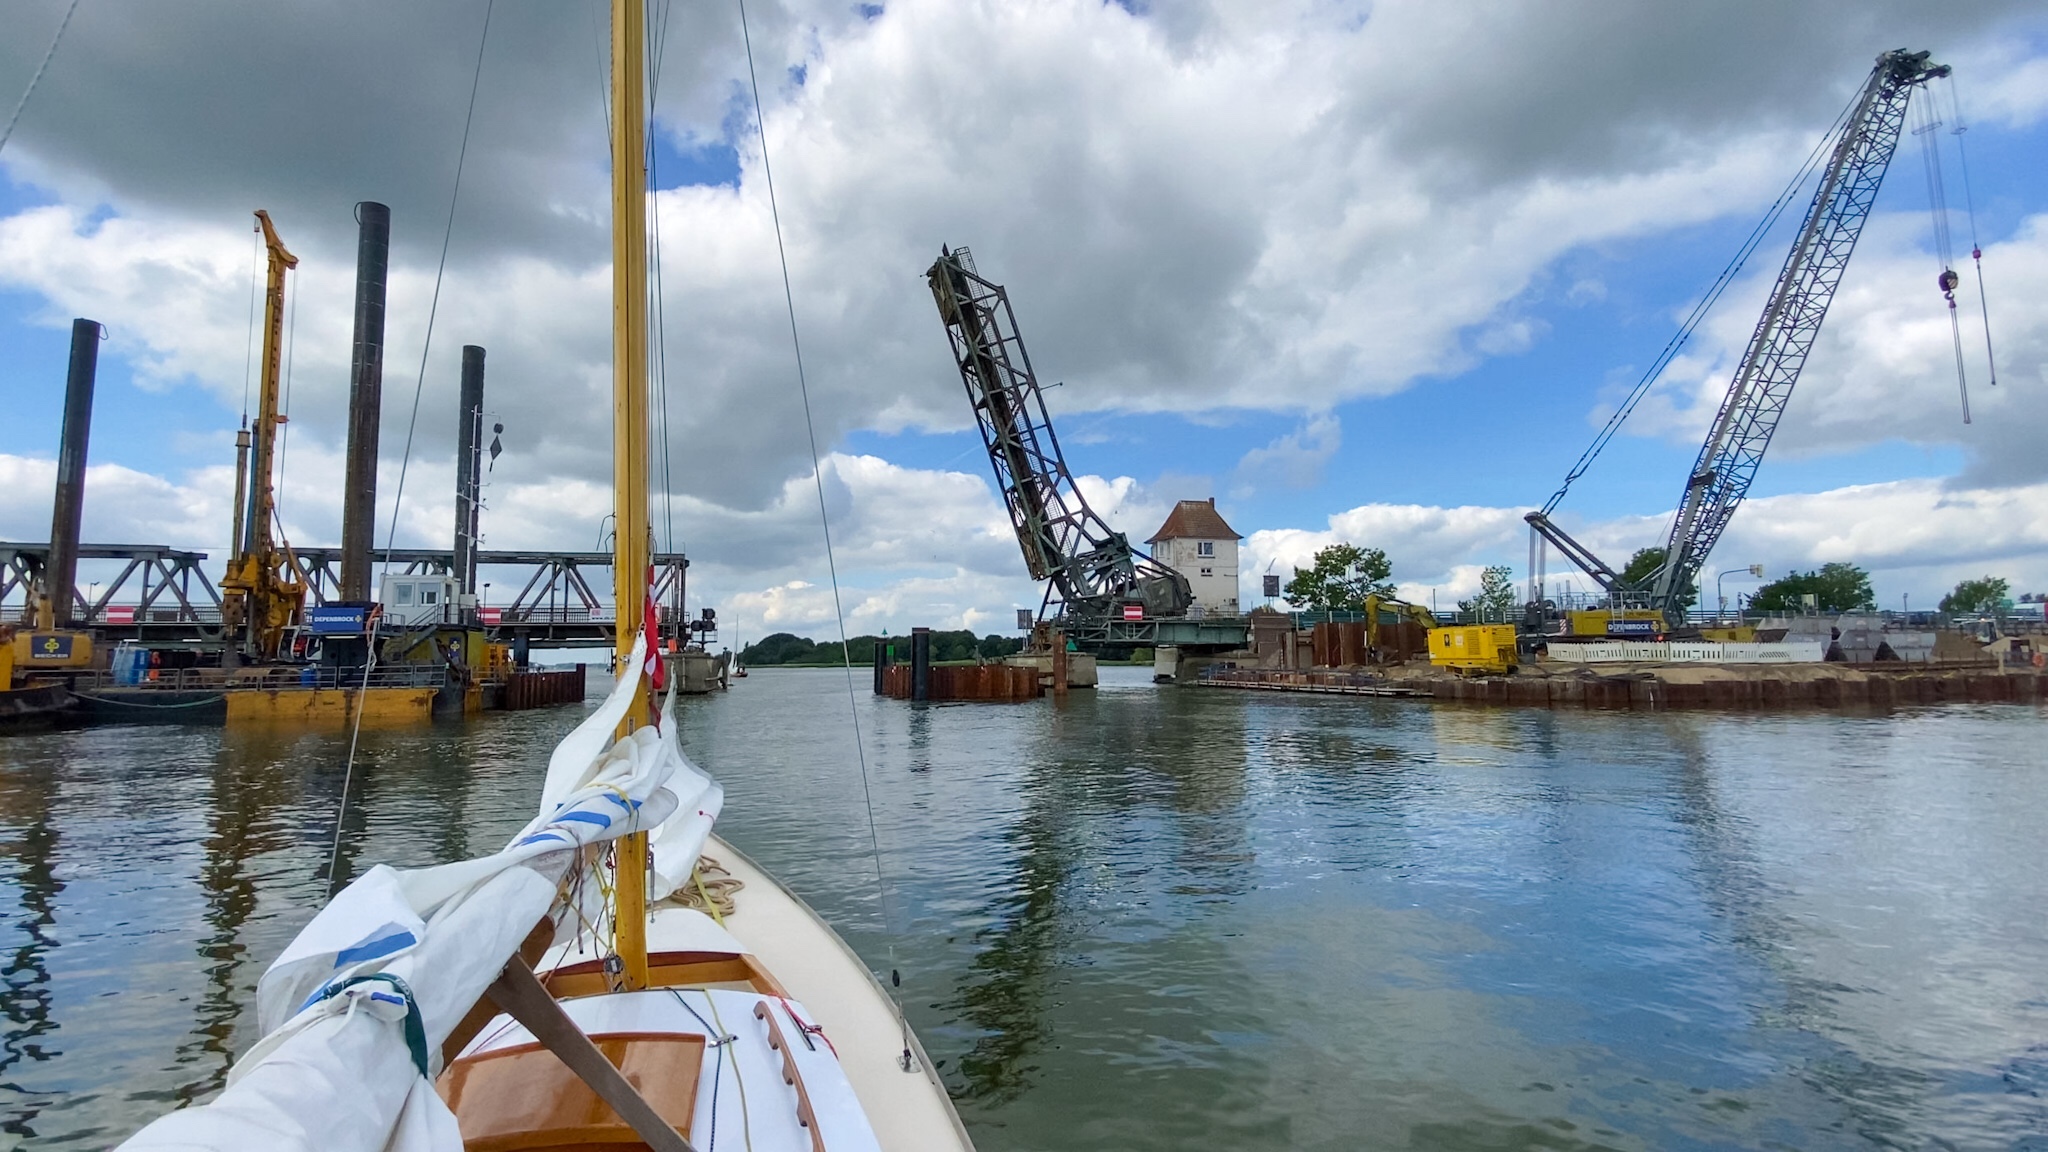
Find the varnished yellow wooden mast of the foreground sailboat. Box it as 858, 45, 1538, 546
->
612, 0, 655, 988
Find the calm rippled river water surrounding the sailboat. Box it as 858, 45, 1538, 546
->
0, 668, 2048, 1152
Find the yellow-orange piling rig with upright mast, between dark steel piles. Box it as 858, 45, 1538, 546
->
221, 209, 305, 662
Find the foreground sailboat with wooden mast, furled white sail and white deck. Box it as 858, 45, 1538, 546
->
123, 0, 973, 1152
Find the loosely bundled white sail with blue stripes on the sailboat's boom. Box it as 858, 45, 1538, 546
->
121, 635, 725, 1152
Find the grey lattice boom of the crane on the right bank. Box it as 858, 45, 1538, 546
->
1651, 49, 1950, 611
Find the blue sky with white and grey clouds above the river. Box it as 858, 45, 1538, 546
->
0, 0, 2048, 637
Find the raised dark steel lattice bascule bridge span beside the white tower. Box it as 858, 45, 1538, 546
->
926, 248, 1194, 619
